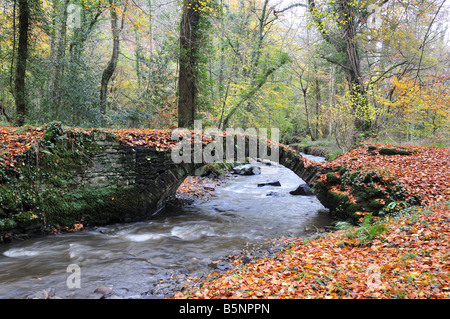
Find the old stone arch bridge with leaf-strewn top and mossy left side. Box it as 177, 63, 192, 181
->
0, 124, 332, 233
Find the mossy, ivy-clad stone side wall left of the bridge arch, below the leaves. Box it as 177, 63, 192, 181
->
0, 123, 195, 241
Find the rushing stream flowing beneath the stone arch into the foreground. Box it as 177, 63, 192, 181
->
0, 159, 331, 298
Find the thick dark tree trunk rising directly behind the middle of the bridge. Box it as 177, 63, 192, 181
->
178, 0, 200, 128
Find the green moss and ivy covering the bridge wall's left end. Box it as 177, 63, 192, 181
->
0, 123, 159, 241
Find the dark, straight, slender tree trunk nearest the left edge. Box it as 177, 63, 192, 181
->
14, 0, 30, 126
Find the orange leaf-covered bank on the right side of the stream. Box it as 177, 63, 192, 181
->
175, 144, 450, 299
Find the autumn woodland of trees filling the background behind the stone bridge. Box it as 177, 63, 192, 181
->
0, 0, 450, 151
